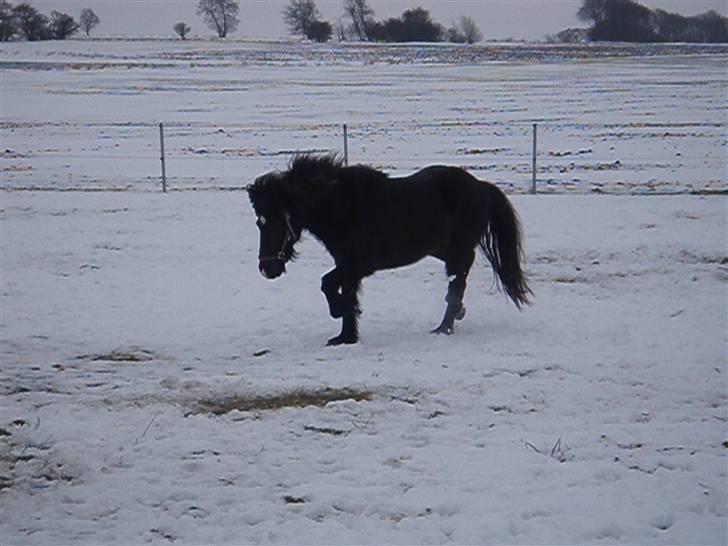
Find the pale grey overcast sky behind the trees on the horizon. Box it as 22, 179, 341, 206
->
28, 0, 728, 40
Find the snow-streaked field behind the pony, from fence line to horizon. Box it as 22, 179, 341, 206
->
0, 41, 728, 193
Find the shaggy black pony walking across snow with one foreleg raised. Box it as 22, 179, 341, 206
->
247, 155, 531, 345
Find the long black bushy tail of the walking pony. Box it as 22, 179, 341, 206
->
479, 181, 533, 309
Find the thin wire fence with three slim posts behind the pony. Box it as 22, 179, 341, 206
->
0, 120, 728, 194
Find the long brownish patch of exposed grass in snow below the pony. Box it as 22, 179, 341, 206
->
192, 388, 374, 415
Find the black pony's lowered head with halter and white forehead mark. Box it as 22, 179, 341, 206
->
247, 172, 301, 279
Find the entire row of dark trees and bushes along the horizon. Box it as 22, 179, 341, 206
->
7, 0, 728, 43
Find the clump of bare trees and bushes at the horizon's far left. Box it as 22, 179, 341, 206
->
0, 0, 100, 42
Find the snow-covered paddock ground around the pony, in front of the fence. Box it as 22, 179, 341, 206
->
0, 188, 728, 544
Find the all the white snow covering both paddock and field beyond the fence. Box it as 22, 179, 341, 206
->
0, 39, 728, 544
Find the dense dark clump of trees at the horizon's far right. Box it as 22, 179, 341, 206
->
577, 0, 728, 43
